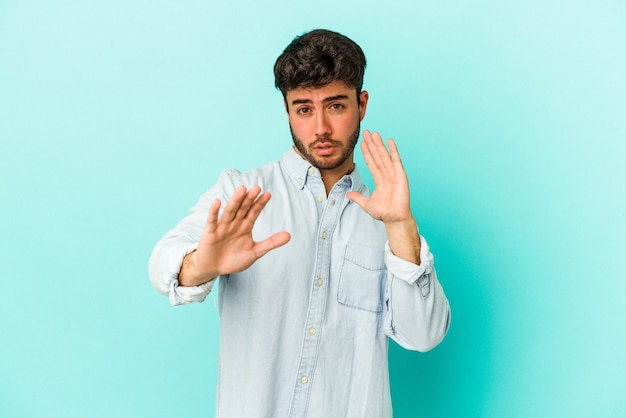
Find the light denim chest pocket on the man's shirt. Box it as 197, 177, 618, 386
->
337, 245, 387, 312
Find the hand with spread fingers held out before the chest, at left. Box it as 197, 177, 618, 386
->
178, 186, 291, 286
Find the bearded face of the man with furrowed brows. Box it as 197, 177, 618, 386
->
285, 81, 368, 174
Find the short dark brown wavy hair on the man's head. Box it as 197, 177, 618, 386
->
274, 29, 365, 98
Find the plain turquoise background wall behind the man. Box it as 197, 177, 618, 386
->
0, 0, 626, 417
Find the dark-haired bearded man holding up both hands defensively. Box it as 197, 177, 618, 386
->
150, 30, 450, 418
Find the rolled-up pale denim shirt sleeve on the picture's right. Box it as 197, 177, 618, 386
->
384, 236, 450, 351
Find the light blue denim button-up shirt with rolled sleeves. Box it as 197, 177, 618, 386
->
150, 149, 450, 418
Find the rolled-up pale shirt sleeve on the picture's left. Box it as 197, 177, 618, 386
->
148, 170, 241, 305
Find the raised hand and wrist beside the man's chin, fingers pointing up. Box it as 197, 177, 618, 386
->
347, 131, 420, 264
